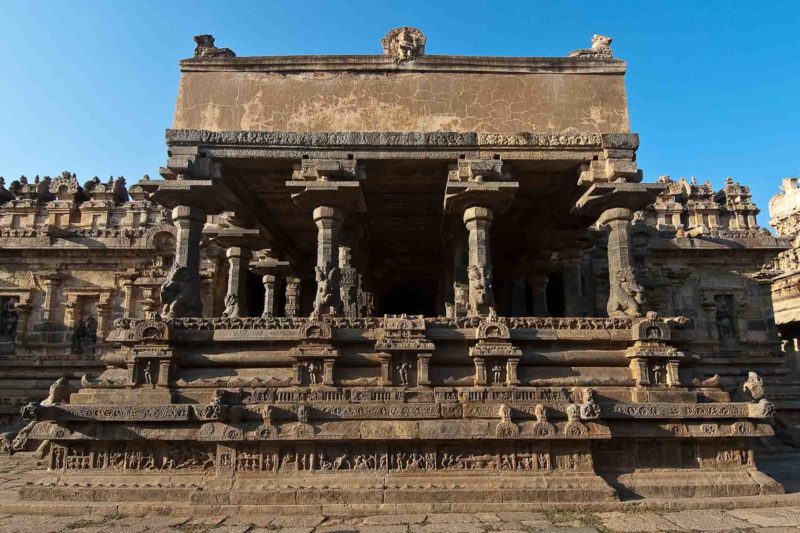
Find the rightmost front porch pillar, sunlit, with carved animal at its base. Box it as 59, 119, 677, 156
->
598, 208, 643, 318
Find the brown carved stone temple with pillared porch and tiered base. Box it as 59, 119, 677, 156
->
0, 28, 798, 512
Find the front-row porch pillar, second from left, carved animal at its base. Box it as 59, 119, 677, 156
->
314, 206, 344, 315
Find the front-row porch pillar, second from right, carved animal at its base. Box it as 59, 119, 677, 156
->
464, 207, 494, 316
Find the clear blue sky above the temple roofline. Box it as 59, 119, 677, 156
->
0, 0, 800, 224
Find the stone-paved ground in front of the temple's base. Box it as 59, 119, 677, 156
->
0, 455, 800, 533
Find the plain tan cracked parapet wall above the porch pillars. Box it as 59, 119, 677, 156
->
173, 64, 630, 133
